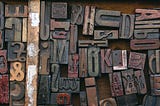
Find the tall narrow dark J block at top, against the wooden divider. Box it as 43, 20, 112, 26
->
40, 1, 51, 40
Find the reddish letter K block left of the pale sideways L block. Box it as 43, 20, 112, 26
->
101, 49, 112, 73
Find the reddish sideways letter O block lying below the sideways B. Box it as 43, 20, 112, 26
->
130, 39, 160, 50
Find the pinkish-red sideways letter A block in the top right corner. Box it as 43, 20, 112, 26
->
135, 9, 160, 21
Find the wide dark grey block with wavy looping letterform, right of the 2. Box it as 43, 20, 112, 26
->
59, 77, 80, 93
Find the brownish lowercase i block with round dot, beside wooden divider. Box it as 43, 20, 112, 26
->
39, 42, 50, 75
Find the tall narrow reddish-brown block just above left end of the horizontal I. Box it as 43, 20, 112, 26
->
69, 25, 78, 53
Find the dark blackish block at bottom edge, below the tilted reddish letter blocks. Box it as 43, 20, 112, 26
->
116, 94, 138, 106
